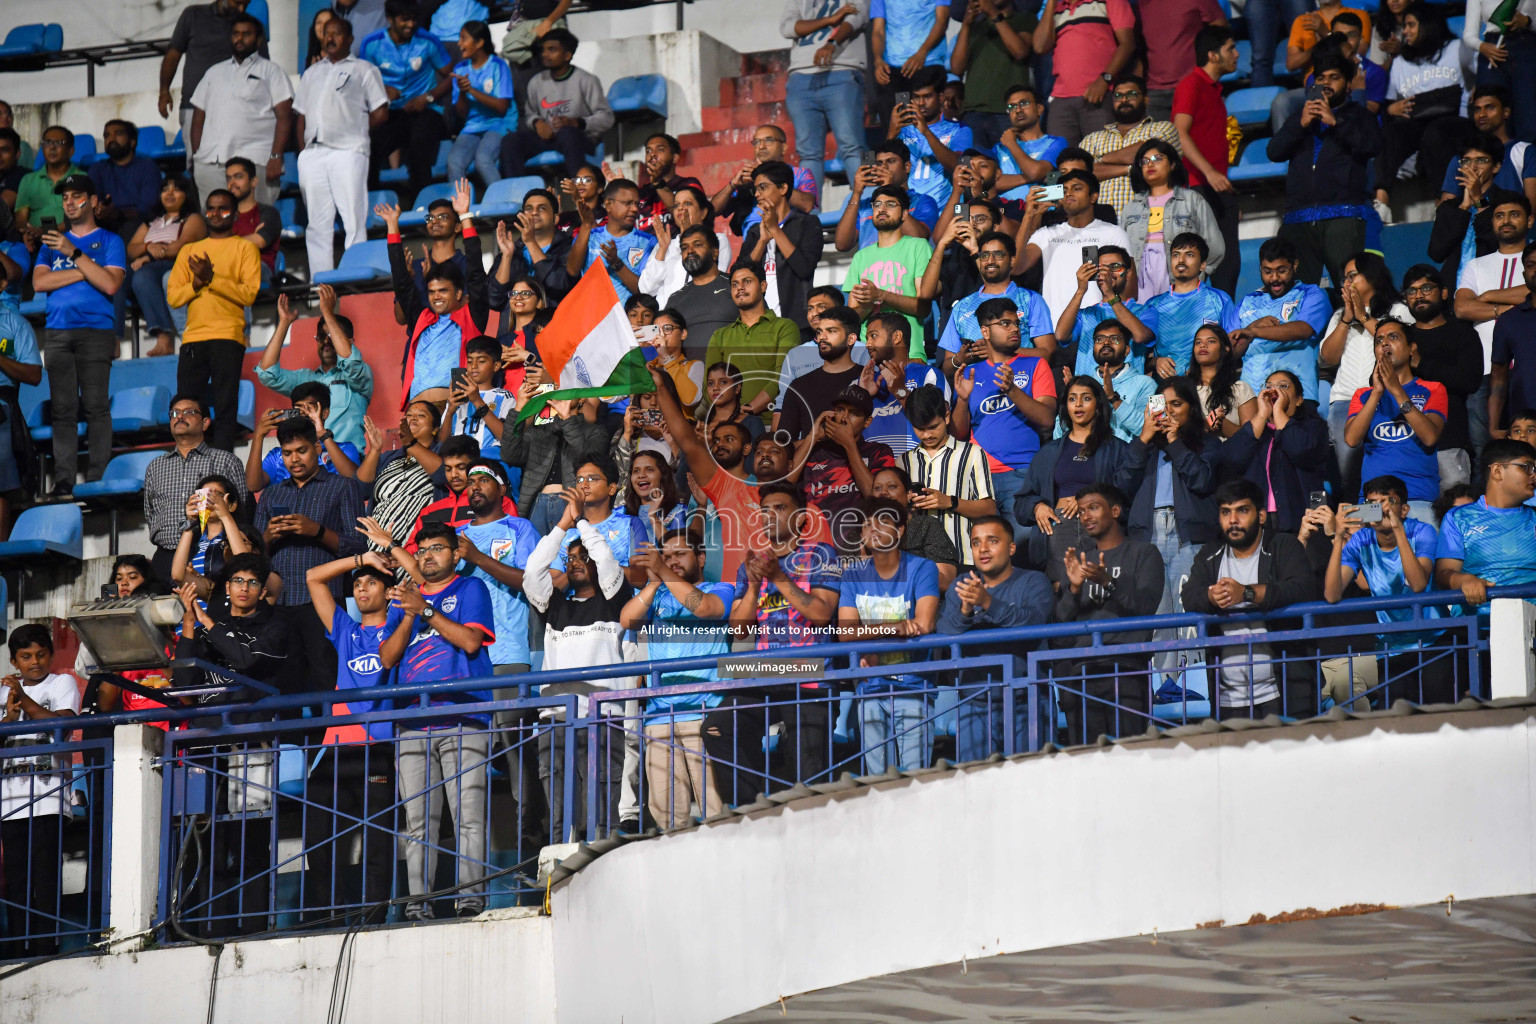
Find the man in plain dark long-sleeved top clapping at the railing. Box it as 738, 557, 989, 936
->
1054, 484, 1163, 745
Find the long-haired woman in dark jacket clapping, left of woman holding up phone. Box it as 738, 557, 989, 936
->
1014, 376, 1127, 568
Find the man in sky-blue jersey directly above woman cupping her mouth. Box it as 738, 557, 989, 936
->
1230, 238, 1344, 402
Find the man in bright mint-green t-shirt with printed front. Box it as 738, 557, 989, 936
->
843, 184, 934, 359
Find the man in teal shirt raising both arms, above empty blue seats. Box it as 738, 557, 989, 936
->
258, 284, 373, 451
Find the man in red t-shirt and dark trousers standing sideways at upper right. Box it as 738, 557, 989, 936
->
1174, 25, 1240, 295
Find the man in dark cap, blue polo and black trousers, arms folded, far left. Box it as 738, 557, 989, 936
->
32, 173, 127, 497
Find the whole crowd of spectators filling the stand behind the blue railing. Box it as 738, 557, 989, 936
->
0, 0, 1536, 951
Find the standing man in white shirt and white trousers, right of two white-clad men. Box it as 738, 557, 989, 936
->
293, 18, 389, 271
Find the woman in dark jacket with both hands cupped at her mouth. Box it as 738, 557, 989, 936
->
1212, 370, 1330, 533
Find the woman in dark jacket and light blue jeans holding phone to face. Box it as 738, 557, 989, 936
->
1121, 376, 1217, 614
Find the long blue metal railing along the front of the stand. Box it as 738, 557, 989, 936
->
0, 586, 1536, 956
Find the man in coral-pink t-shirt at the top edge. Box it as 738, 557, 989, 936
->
1032, 0, 1137, 146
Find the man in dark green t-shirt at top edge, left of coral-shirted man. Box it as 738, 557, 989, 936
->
949, 0, 1040, 152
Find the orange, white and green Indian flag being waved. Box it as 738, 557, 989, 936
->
515, 259, 656, 425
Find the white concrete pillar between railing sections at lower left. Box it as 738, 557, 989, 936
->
109, 725, 166, 953
